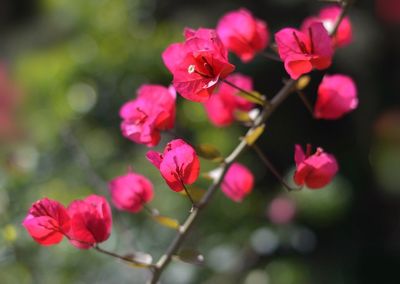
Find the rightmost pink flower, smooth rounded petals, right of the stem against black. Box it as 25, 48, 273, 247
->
314, 74, 358, 119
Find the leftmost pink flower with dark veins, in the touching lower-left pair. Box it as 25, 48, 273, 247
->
22, 198, 70, 246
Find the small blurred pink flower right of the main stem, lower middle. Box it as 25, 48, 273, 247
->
221, 163, 254, 202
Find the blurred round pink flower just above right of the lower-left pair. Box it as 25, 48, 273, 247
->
109, 169, 154, 213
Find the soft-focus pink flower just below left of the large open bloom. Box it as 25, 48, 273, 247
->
120, 85, 176, 147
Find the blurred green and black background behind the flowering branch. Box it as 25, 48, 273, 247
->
0, 0, 400, 284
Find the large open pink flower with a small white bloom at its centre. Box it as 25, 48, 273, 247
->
162, 28, 235, 102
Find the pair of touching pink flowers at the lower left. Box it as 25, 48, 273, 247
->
22, 195, 112, 249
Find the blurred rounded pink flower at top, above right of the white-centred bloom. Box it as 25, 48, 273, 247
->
217, 9, 269, 62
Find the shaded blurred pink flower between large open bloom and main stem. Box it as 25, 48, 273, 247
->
204, 73, 254, 126
